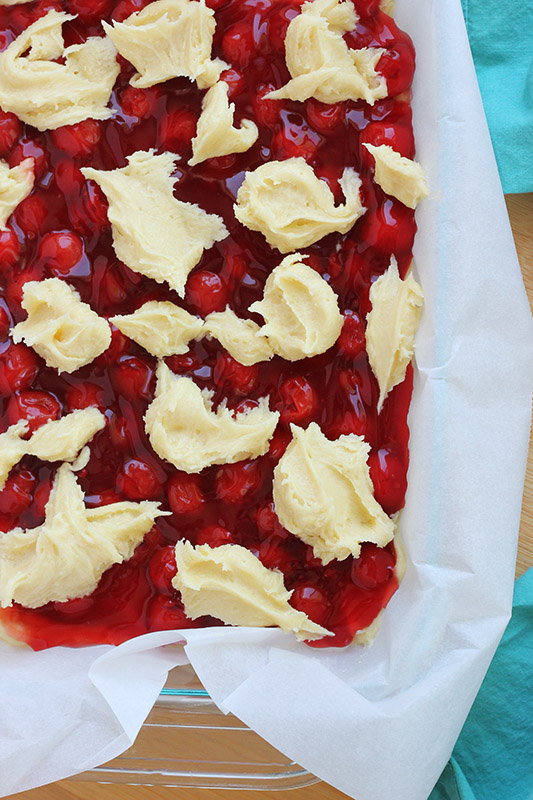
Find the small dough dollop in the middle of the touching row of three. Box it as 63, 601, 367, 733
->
203, 308, 274, 367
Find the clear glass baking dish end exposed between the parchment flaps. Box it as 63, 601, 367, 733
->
71, 666, 318, 791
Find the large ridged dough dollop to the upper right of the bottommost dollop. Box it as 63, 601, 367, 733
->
273, 422, 394, 564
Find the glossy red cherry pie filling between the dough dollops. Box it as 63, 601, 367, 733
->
0, 0, 416, 649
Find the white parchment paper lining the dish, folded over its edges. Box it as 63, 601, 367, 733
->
0, 0, 533, 800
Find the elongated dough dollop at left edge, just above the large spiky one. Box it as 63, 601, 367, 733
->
0, 408, 105, 491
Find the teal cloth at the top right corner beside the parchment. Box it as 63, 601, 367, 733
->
462, 0, 533, 193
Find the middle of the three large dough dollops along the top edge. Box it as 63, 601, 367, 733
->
102, 0, 227, 89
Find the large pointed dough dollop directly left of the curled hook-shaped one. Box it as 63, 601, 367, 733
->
81, 150, 228, 297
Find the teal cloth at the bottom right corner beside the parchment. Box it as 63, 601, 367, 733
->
429, 568, 533, 800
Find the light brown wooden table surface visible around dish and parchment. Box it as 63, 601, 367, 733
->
8, 194, 533, 800
